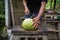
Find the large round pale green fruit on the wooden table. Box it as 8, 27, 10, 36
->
22, 18, 35, 30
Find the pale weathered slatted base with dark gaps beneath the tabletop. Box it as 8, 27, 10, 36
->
13, 35, 48, 40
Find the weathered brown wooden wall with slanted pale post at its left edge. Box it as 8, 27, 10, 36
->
10, 0, 24, 26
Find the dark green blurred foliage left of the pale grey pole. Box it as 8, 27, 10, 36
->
0, 0, 5, 34
